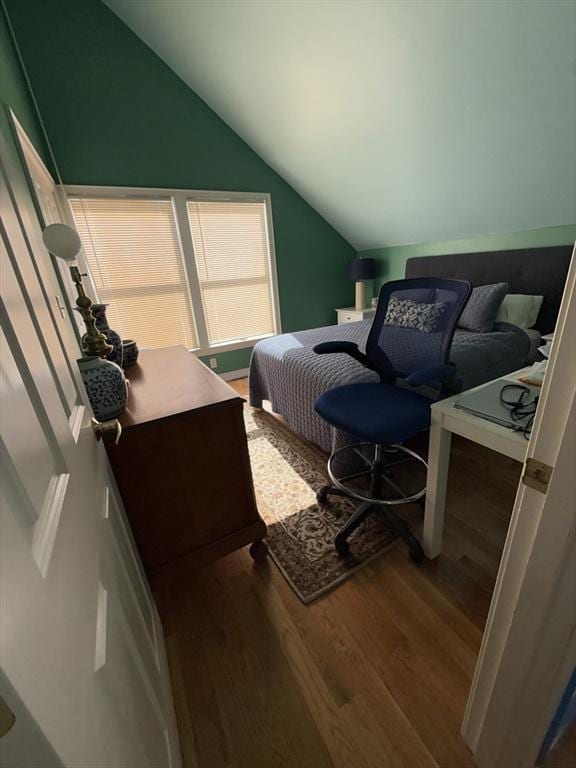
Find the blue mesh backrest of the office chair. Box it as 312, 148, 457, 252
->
366, 277, 472, 378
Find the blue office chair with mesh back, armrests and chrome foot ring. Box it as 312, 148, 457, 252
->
314, 278, 471, 562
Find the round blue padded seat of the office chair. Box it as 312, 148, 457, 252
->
314, 384, 431, 445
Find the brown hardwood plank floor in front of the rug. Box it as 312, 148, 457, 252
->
154, 381, 520, 768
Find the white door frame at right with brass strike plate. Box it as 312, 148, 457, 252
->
462, 248, 576, 768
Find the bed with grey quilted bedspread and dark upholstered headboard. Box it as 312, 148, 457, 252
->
250, 246, 571, 451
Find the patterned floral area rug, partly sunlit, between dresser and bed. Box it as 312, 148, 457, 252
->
244, 406, 397, 603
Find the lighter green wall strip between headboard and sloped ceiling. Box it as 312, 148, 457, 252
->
359, 225, 576, 290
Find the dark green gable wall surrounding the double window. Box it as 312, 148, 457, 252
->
6, 0, 354, 372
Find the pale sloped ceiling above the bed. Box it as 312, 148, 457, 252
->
105, 0, 576, 249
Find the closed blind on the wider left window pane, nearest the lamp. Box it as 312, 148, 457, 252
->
70, 197, 198, 348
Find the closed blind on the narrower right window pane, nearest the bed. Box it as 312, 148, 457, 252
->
187, 200, 276, 344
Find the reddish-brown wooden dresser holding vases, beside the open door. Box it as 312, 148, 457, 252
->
105, 347, 267, 574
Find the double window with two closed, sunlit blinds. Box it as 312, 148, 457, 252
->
68, 188, 279, 350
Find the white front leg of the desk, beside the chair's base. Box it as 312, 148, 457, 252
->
422, 412, 452, 559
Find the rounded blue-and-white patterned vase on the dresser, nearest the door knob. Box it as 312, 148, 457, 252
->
77, 357, 128, 421
